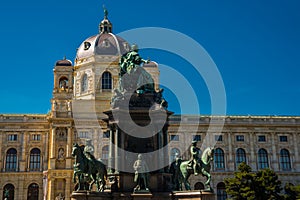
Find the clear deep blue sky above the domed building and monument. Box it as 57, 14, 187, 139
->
0, 0, 300, 115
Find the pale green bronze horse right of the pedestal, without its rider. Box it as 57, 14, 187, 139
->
180, 147, 214, 191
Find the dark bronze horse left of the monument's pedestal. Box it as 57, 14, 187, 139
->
72, 144, 107, 192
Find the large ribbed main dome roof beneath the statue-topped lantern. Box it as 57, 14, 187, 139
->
76, 32, 130, 59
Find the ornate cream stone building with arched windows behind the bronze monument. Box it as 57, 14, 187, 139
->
0, 12, 300, 200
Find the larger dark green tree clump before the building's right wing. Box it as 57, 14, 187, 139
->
225, 163, 284, 200
